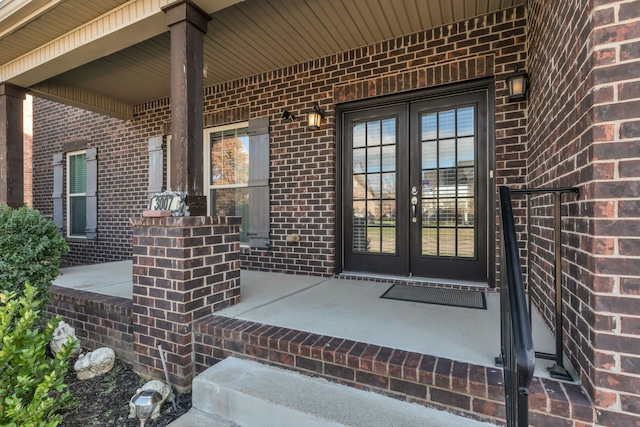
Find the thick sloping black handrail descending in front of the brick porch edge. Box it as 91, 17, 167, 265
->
500, 187, 535, 427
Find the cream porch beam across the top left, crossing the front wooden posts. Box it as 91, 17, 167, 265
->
0, 0, 243, 87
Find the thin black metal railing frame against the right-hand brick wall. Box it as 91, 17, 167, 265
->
509, 187, 580, 381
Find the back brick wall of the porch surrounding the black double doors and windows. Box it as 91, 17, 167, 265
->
34, 7, 526, 275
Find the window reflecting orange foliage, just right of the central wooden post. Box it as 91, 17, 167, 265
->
205, 123, 250, 243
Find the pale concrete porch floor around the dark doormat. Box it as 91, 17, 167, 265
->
53, 261, 555, 377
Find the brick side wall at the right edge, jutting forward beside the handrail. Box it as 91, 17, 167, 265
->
528, 1, 640, 426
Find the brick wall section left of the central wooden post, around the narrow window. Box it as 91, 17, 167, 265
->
33, 98, 156, 264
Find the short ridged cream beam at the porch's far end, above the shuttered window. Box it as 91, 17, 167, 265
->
29, 80, 133, 120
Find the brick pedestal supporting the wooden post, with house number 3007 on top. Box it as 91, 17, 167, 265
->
133, 216, 241, 389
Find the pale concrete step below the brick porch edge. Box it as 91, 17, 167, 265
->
169, 357, 495, 427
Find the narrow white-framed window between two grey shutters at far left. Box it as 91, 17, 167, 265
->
67, 151, 87, 237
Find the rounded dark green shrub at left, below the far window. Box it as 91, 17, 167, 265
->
0, 205, 68, 300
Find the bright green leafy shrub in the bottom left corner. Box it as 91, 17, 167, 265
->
0, 284, 74, 427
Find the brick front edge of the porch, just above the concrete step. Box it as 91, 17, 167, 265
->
194, 315, 594, 427
